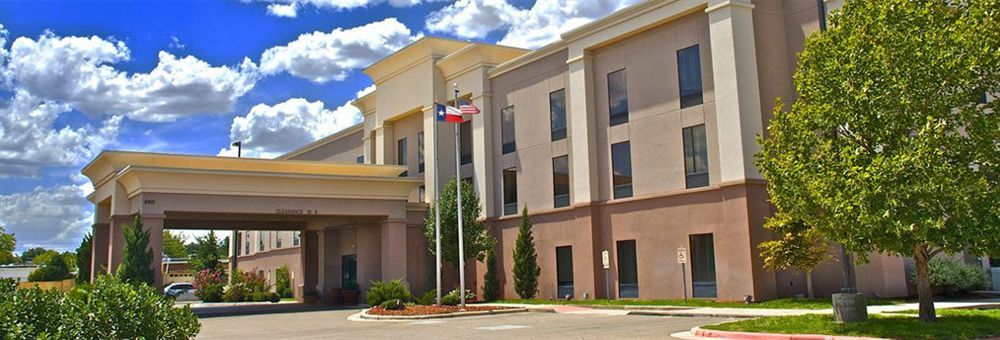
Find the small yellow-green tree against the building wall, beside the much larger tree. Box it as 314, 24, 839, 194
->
757, 214, 830, 299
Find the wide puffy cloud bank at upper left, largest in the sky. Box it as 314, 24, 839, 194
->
3, 32, 259, 122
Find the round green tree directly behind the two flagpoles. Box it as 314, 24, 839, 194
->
424, 178, 490, 269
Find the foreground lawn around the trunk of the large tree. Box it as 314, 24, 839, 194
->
702, 309, 1000, 339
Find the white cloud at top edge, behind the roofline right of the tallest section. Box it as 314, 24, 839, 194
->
425, 0, 638, 48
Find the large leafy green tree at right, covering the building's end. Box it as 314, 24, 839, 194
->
756, 0, 1000, 322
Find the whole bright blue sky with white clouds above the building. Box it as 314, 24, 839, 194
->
0, 0, 635, 250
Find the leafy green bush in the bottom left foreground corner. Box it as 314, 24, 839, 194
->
0, 276, 201, 339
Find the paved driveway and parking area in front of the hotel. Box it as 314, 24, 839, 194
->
198, 310, 728, 340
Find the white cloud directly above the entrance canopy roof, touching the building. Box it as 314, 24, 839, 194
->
219, 98, 361, 158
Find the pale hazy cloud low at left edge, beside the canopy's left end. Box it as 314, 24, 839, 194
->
0, 185, 93, 250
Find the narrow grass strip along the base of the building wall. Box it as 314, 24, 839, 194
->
497, 298, 905, 309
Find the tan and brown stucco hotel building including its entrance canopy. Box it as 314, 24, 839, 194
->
84, 0, 907, 300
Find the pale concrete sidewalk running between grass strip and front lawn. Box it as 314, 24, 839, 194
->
486, 299, 1000, 318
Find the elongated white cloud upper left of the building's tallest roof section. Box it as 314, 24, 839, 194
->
260, 18, 421, 83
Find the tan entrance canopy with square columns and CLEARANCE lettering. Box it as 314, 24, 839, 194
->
82, 151, 426, 288
